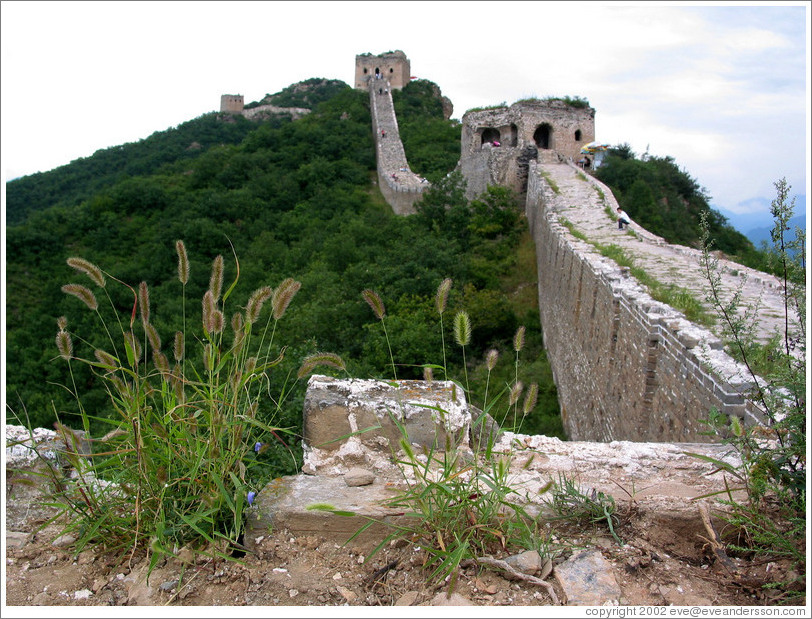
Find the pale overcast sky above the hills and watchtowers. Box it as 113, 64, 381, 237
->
0, 1, 810, 220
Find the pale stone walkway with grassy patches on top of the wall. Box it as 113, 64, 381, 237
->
540, 163, 796, 348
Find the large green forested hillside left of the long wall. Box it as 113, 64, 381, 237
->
6, 80, 562, 474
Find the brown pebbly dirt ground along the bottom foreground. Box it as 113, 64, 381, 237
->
3, 502, 805, 616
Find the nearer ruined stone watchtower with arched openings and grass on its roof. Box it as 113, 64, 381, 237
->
459, 99, 595, 199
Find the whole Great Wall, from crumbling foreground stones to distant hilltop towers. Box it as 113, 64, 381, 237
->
6, 52, 800, 605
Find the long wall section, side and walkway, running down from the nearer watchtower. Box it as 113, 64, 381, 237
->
526, 162, 780, 442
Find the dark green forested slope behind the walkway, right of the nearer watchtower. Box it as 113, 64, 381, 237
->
595, 144, 768, 270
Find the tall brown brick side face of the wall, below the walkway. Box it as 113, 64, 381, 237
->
526, 162, 758, 442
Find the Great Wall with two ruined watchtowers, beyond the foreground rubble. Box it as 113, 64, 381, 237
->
356, 50, 782, 442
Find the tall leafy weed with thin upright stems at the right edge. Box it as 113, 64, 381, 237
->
702, 179, 806, 599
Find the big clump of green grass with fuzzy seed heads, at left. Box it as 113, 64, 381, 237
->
38, 241, 343, 570
